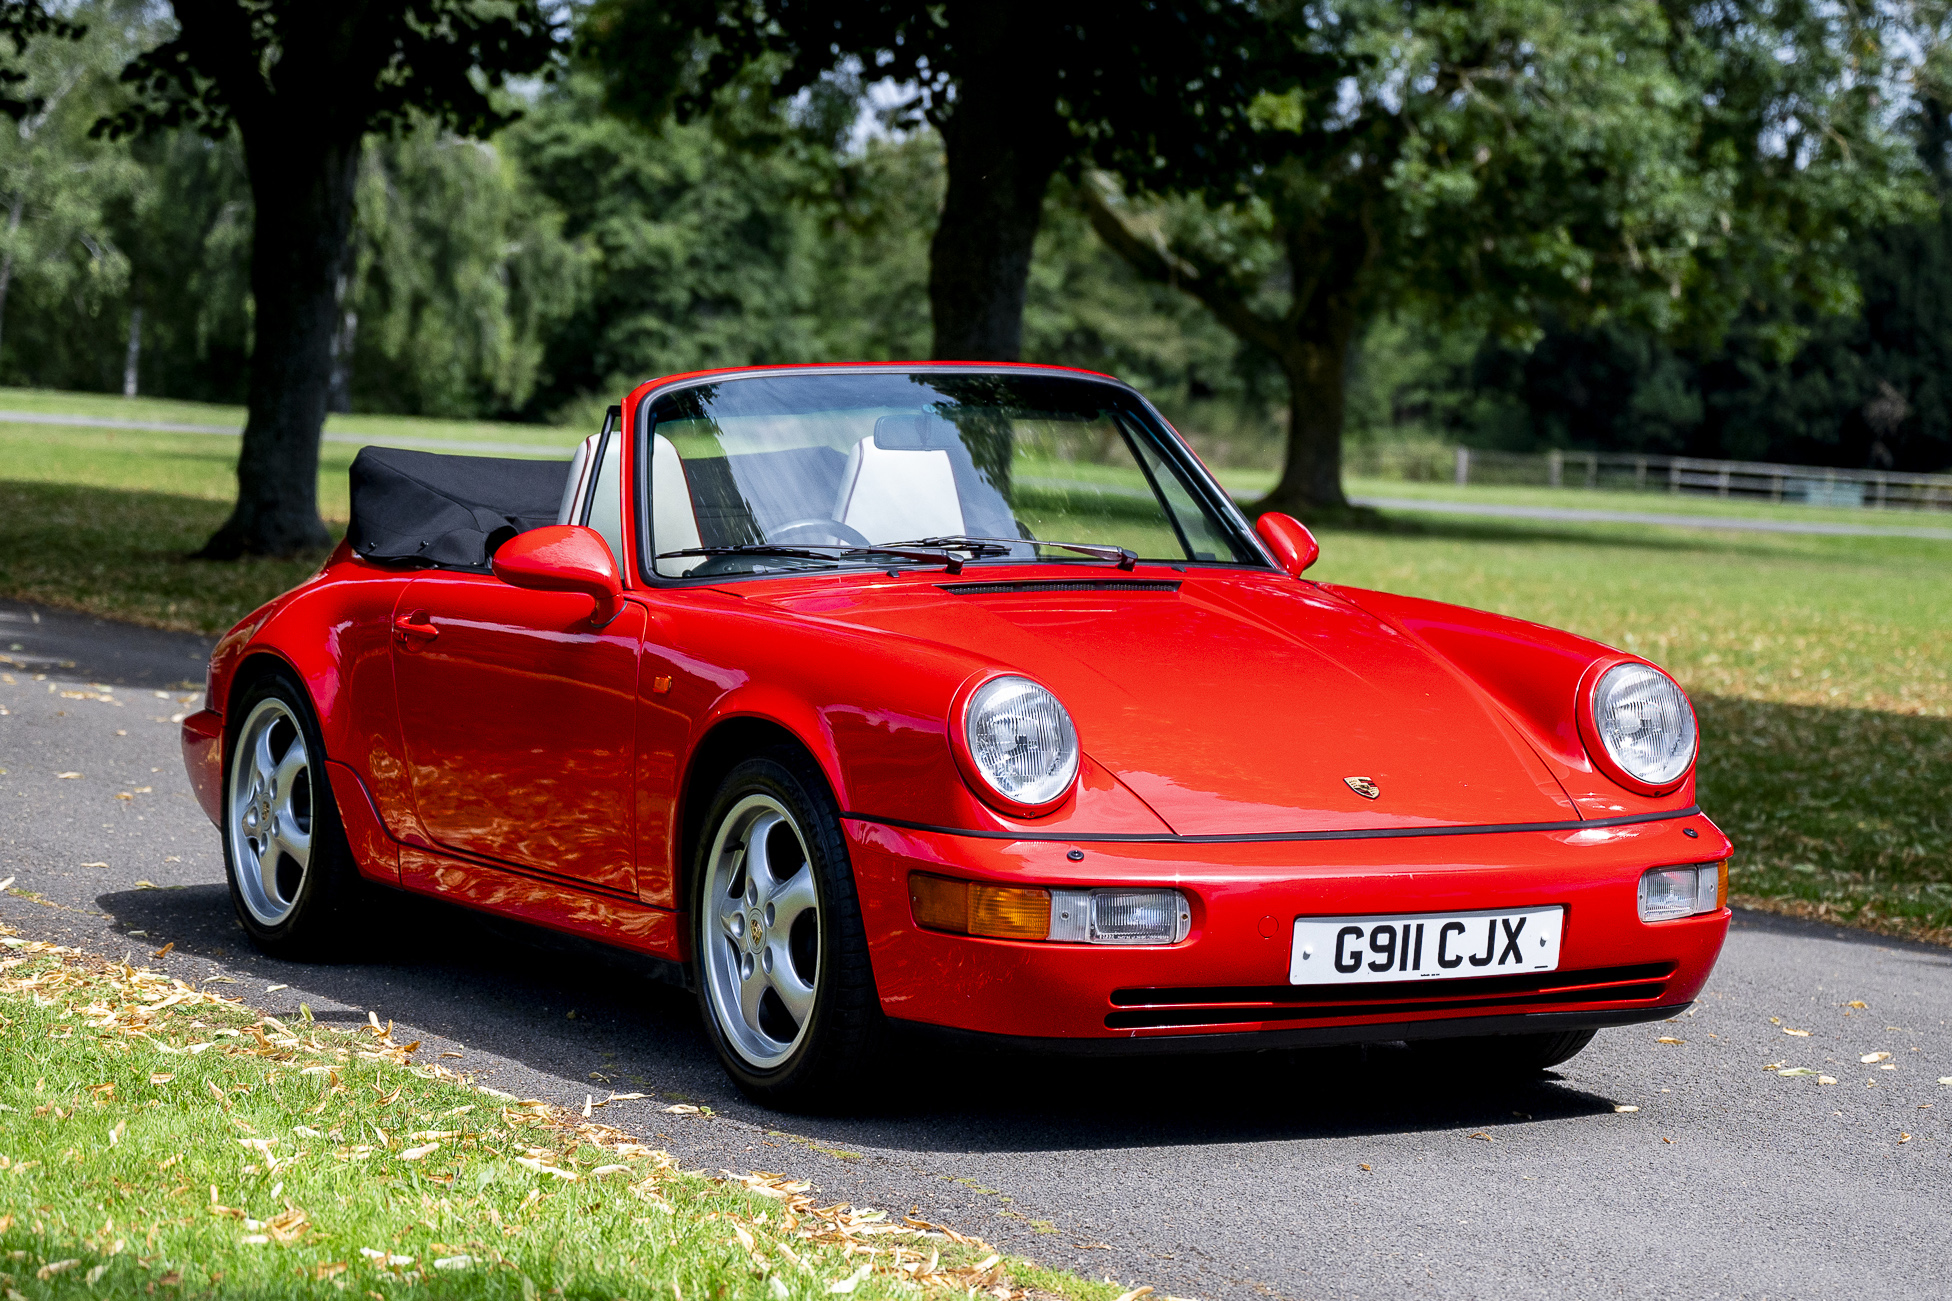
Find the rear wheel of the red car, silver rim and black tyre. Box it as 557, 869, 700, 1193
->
223, 672, 359, 959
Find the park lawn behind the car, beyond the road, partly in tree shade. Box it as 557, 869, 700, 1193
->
0, 389, 1952, 942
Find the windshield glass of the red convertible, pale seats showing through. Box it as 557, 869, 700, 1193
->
640, 371, 1265, 578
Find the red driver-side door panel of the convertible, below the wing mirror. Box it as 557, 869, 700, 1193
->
394, 572, 644, 895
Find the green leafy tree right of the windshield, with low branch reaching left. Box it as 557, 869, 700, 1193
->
1081, 0, 1907, 516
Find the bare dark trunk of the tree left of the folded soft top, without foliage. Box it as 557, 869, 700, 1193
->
197, 132, 359, 561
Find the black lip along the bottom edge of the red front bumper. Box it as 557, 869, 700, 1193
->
888, 1002, 1694, 1057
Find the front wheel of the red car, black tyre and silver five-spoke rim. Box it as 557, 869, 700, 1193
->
691, 748, 884, 1110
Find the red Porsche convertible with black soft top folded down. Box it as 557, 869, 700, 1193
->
183, 363, 1729, 1104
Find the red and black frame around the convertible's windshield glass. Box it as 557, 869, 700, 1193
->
630, 361, 1279, 588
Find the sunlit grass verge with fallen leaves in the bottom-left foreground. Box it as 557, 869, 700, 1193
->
0, 925, 1118, 1301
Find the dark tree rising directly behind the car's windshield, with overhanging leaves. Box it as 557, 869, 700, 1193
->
588, 0, 1320, 361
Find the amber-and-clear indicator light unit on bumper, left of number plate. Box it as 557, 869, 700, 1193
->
908, 871, 1193, 944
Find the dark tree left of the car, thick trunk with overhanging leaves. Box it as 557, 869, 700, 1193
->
102, 0, 556, 559
